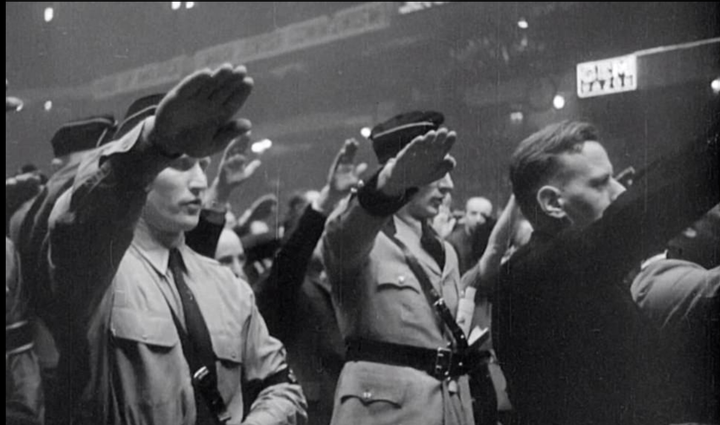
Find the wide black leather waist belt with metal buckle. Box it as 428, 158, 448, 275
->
346, 339, 491, 380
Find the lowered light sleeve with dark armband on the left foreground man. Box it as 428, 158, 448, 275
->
242, 290, 307, 425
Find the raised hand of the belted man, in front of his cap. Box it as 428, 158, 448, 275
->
378, 128, 457, 196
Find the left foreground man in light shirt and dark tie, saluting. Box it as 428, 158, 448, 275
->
50, 65, 305, 425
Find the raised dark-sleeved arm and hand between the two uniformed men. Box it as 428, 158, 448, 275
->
255, 140, 366, 425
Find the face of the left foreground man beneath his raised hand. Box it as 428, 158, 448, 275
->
143, 155, 210, 233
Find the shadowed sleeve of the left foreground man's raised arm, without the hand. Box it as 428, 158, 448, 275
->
48, 119, 173, 314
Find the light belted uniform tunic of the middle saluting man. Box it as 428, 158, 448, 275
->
323, 198, 474, 425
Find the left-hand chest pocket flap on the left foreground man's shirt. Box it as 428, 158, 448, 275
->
111, 307, 180, 348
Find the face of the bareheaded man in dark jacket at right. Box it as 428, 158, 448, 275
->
553, 141, 625, 227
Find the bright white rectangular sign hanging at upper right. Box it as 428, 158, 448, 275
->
577, 55, 637, 98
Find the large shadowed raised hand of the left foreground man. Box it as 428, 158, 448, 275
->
148, 65, 253, 158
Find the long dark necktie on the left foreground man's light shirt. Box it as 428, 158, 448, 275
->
168, 249, 217, 425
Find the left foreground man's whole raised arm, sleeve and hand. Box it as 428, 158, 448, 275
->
49, 65, 252, 308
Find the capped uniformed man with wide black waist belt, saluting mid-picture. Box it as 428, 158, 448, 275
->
323, 112, 494, 425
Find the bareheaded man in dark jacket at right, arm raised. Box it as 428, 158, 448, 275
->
492, 122, 720, 424
